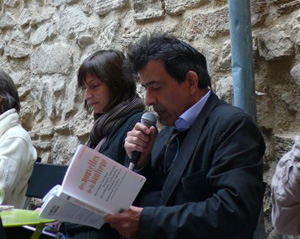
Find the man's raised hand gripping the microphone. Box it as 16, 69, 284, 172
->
124, 123, 156, 169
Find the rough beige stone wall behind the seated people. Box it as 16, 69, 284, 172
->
0, 0, 300, 238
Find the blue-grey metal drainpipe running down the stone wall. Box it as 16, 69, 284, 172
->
228, 0, 266, 239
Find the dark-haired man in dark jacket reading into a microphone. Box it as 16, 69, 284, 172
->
105, 35, 265, 239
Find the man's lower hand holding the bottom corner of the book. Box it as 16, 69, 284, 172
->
104, 206, 143, 237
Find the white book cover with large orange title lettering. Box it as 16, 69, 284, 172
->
62, 145, 145, 214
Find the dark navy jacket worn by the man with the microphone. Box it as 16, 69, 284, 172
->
139, 93, 265, 239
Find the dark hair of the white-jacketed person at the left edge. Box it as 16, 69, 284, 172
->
0, 68, 20, 114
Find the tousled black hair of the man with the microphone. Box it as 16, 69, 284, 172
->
128, 33, 211, 89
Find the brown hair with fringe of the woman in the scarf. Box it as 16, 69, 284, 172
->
77, 50, 136, 114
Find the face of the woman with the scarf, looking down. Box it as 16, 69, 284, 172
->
83, 74, 110, 113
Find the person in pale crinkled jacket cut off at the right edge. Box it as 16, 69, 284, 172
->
271, 136, 300, 235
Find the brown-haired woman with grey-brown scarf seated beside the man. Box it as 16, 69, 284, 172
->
65, 50, 144, 239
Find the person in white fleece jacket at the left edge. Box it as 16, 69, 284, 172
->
0, 69, 37, 208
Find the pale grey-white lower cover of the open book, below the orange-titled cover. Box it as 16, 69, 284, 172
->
39, 196, 104, 229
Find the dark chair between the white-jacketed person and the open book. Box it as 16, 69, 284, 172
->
23, 162, 68, 238
